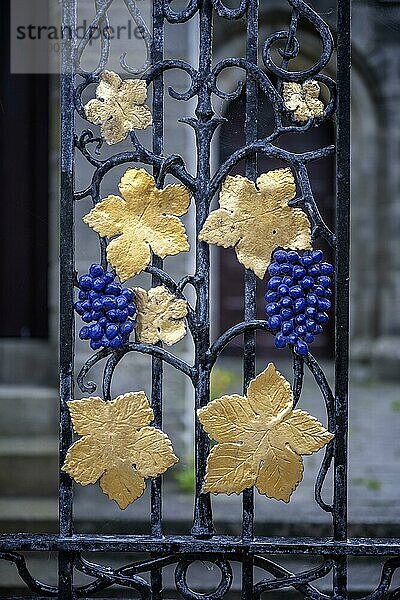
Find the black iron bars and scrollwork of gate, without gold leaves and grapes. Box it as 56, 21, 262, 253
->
0, 0, 390, 600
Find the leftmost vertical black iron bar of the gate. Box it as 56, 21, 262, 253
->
59, 0, 77, 600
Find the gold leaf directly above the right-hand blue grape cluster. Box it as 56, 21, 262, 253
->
199, 168, 311, 279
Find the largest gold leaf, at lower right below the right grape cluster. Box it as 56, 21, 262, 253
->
197, 363, 333, 502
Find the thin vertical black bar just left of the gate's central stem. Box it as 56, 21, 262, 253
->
150, 2, 164, 600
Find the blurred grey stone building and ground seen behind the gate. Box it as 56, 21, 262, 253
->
0, 0, 400, 598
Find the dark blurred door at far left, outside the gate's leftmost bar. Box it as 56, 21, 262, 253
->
0, 0, 49, 338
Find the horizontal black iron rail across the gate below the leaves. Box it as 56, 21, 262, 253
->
0, 533, 400, 556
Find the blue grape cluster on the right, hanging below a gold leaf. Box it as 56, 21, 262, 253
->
265, 250, 334, 356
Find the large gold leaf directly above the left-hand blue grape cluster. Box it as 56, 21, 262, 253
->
83, 169, 190, 281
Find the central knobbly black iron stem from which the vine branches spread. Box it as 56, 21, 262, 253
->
191, 0, 219, 538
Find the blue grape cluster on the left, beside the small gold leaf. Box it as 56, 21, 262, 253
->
74, 264, 136, 350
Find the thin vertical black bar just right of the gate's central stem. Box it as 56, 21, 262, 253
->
242, 0, 259, 600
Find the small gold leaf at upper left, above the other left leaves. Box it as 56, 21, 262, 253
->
85, 71, 152, 145
